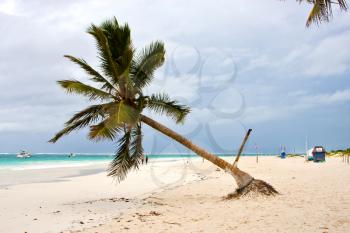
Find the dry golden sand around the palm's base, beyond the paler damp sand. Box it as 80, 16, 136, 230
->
83, 158, 350, 233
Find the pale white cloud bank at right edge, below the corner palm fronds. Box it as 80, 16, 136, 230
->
241, 29, 350, 79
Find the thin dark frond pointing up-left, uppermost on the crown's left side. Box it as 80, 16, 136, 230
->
64, 55, 116, 92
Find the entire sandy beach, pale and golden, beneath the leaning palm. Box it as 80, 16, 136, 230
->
0, 157, 350, 233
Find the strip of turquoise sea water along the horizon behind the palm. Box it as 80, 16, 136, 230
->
0, 153, 271, 170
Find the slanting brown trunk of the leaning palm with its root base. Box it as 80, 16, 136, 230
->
141, 115, 277, 197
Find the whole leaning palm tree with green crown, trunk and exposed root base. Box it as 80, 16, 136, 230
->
50, 18, 277, 198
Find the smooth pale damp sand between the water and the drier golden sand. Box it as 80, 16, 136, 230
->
0, 158, 205, 233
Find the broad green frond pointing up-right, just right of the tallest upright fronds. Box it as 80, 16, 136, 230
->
131, 41, 165, 89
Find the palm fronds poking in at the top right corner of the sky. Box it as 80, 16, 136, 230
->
297, 0, 348, 27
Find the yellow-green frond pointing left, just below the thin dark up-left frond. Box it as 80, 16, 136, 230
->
57, 80, 114, 100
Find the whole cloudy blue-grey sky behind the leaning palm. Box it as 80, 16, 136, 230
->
0, 0, 350, 153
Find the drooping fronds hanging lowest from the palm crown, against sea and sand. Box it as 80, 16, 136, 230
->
108, 125, 143, 182
